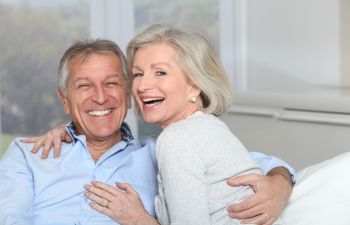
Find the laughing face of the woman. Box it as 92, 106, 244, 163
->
132, 43, 200, 127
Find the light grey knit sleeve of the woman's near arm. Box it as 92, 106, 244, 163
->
157, 133, 210, 225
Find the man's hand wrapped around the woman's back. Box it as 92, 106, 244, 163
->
227, 167, 293, 225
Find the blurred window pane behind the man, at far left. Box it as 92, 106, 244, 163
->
0, 0, 89, 155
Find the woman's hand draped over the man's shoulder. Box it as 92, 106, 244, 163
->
21, 123, 72, 159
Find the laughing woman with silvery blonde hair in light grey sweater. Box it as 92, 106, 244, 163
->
127, 25, 268, 225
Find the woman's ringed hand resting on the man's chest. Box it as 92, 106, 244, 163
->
85, 181, 159, 225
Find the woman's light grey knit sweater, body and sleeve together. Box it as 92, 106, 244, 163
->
155, 112, 261, 225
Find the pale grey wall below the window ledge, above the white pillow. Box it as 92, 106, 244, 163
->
223, 106, 350, 169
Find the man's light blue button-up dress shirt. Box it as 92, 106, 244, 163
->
0, 123, 295, 225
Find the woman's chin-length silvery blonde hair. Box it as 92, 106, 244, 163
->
126, 24, 233, 116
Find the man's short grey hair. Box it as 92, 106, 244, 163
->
57, 39, 130, 96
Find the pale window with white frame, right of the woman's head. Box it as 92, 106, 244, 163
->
221, 0, 350, 113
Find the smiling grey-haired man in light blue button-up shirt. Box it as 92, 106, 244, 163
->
0, 40, 292, 225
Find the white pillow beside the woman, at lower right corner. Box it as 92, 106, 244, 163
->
281, 152, 350, 225
